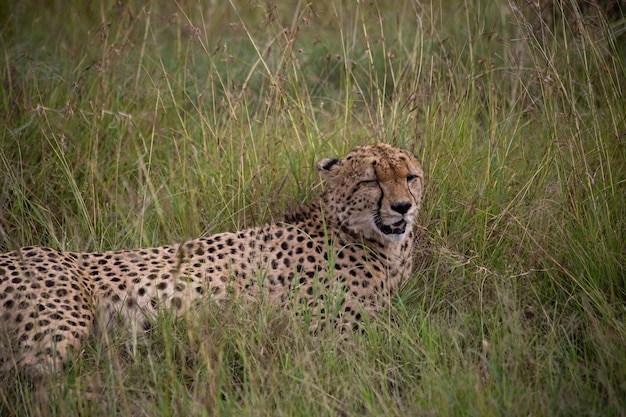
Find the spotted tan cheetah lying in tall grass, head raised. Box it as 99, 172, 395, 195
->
0, 144, 424, 375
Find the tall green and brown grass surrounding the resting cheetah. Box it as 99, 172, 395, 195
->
0, 0, 626, 416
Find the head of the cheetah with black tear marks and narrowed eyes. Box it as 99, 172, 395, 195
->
318, 144, 424, 242
